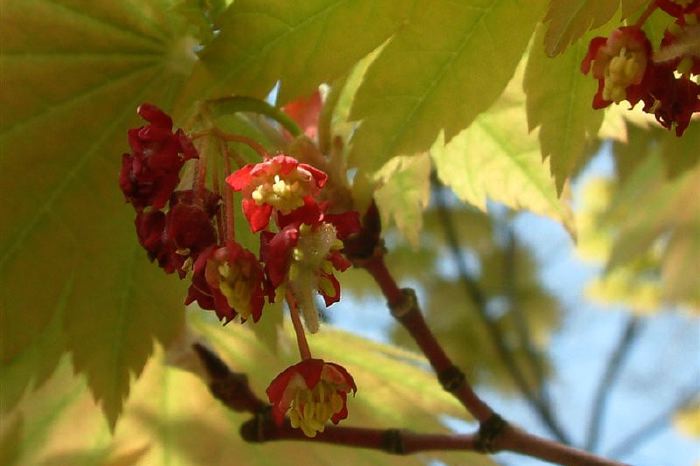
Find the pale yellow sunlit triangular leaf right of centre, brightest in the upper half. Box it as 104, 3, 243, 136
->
431, 62, 573, 231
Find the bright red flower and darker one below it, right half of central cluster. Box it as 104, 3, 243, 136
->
226, 155, 360, 333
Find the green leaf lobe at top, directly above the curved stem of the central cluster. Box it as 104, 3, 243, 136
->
179, 0, 405, 110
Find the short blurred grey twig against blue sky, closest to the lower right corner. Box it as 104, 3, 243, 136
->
585, 317, 641, 451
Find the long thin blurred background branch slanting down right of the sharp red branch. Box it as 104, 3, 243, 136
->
433, 181, 571, 444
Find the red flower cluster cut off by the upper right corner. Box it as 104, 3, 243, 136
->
581, 0, 700, 136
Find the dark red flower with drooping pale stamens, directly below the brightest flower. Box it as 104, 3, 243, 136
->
260, 202, 360, 333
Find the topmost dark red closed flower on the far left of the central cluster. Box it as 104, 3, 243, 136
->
119, 104, 198, 210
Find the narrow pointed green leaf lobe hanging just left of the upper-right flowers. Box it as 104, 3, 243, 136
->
524, 28, 604, 193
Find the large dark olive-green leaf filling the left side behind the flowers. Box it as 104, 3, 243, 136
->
0, 0, 193, 425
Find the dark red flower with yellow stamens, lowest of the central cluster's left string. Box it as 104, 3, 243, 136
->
185, 242, 264, 322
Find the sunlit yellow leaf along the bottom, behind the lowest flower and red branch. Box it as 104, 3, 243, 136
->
0, 312, 493, 466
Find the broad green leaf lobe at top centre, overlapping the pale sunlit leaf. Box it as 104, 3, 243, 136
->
349, 0, 543, 177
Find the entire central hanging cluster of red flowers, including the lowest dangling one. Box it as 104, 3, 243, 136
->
119, 104, 360, 437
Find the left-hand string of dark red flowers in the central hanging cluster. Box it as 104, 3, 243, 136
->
119, 104, 264, 322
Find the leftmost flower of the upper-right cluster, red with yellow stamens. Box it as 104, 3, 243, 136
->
581, 26, 651, 108
